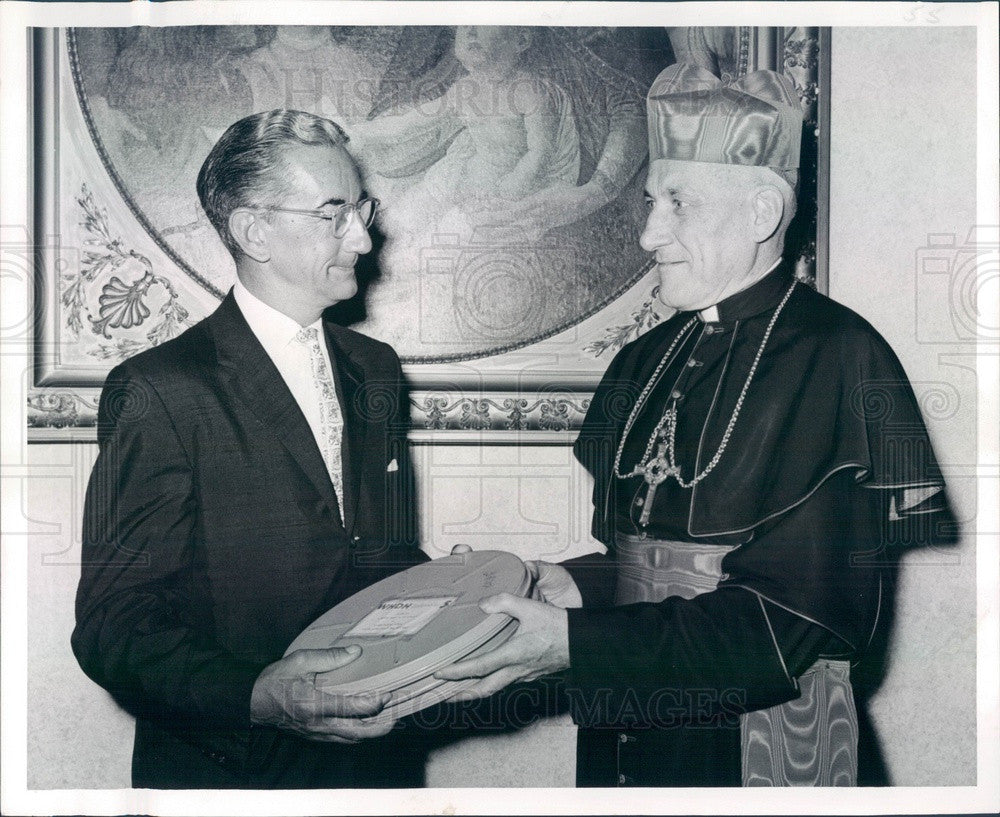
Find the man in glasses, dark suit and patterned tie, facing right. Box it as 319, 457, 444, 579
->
72, 110, 426, 788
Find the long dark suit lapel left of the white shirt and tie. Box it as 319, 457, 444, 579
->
208, 292, 348, 515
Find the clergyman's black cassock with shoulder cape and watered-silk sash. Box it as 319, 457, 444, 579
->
564, 263, 955, 786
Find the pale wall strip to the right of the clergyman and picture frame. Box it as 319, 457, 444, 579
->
830, 27, 976, 785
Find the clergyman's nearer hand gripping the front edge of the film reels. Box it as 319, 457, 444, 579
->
434, 593, 569, 700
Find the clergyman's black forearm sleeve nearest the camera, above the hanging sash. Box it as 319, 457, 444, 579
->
566, 588, 838, 728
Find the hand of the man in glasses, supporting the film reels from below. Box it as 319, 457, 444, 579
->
250, 645, 394, 743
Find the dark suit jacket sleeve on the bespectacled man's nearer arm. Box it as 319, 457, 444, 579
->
72, 367, 263, 754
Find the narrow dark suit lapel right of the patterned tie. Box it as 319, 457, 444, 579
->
323, 321, 368, 534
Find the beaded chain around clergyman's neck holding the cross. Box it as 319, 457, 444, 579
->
613, 281, 797, 488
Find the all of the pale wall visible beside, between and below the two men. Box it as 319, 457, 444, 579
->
23, 28, 976, 788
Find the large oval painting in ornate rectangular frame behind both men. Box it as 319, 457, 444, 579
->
29, 26, 823, 431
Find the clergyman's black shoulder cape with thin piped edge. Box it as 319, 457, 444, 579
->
574, 285, 943, 544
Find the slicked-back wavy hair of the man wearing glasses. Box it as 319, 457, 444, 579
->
198, 108, 347, 259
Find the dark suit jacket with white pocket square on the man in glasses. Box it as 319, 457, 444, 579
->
72, 293, 426, 788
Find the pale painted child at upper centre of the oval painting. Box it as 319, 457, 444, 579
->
354, 26, 580, 247
